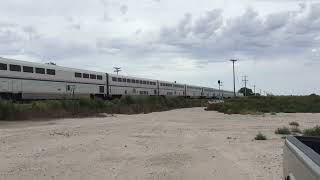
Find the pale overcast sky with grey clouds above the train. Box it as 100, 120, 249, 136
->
0, 0, 320, 94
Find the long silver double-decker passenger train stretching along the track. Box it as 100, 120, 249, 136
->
0, 58, 241, 100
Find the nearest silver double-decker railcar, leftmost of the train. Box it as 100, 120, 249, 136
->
0, 58, 106, 99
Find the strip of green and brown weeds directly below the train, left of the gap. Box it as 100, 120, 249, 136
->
0, 96, 206, 120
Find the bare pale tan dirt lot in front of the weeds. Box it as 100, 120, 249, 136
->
0, 108, 320, 180
